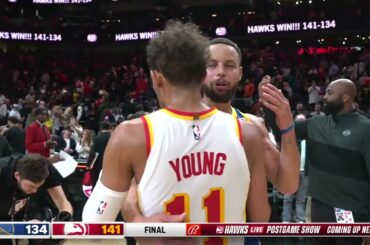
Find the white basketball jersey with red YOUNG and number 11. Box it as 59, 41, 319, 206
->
138, 109, 250, 244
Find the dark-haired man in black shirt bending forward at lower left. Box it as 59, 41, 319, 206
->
0, 154, 72, 221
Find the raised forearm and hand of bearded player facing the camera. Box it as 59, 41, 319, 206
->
259, 76, 300, 194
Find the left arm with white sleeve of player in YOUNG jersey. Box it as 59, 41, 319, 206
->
83, 119, 147, 221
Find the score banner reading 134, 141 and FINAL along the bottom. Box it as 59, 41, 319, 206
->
0, 222, 370, 239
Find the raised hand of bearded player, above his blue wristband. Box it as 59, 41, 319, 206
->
261, 82, 293, 129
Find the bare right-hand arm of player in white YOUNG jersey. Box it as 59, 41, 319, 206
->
241, 121, 271, 222
